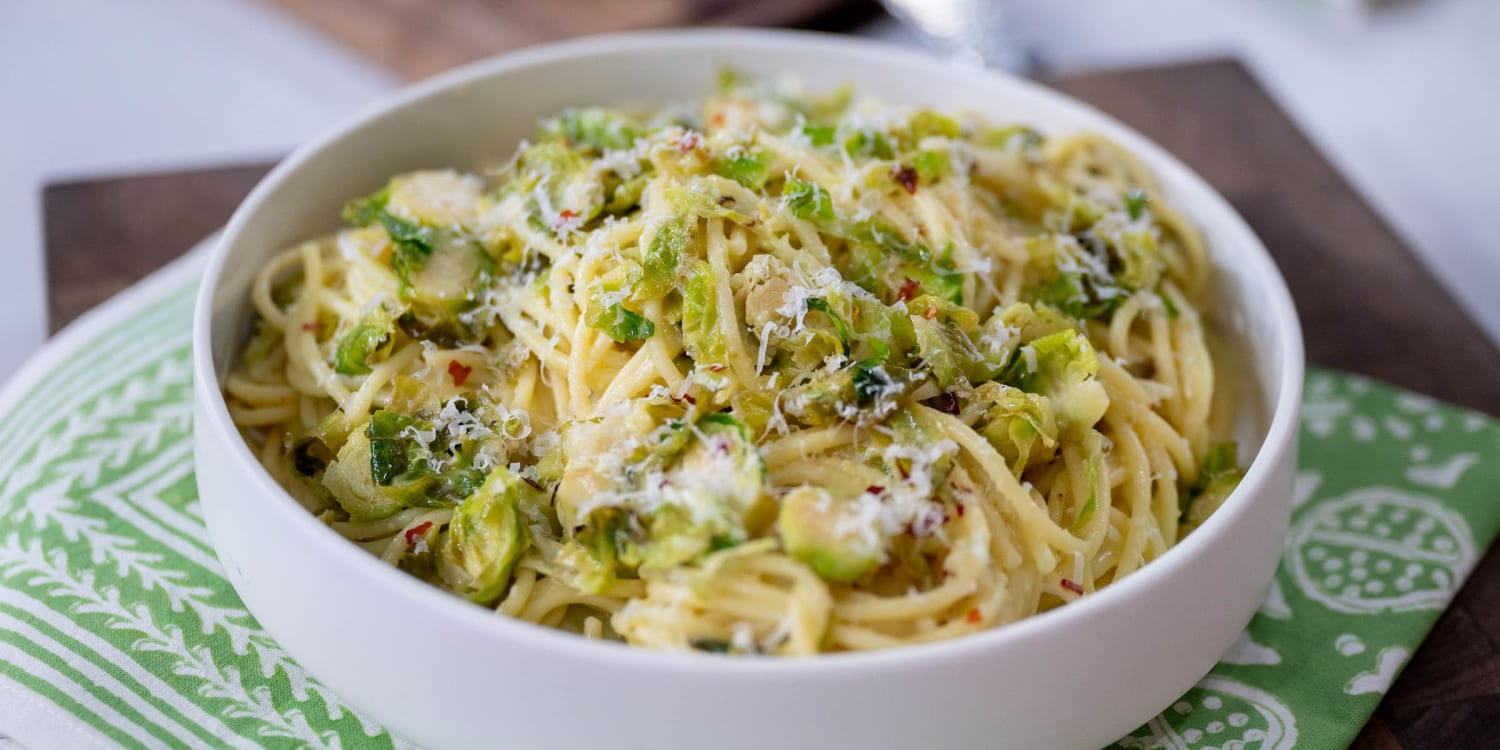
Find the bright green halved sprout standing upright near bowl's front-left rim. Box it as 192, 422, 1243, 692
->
438, 468, 528, 605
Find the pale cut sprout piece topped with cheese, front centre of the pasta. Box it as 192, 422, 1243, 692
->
776, 486, 885, 584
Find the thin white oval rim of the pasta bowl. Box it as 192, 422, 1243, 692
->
192, 29, 1305, 680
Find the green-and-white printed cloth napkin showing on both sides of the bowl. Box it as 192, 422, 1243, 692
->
0, 255, 1500, 750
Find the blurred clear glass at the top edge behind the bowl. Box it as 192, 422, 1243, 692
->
881, 0, 1037, 74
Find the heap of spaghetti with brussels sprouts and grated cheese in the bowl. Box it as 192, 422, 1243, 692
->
225, 77, 1239, 654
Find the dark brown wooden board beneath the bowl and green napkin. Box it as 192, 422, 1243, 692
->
45, 55, 1500, 749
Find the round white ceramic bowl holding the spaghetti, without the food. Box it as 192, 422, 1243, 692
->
194, 32, 1302, 750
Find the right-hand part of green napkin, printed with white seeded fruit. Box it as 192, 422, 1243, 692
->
1116, 369, 1500, 750
